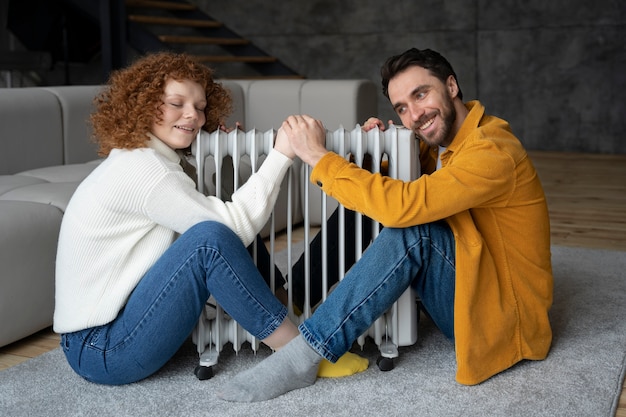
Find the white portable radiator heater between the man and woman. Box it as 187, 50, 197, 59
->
192, 125, 420, 379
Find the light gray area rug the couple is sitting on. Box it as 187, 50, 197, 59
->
0, 247, 626, 417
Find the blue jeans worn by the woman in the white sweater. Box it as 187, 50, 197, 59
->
61, 222, 287, 385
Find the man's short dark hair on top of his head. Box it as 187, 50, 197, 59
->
380, 48, 463, 99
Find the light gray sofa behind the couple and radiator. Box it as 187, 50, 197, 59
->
0, 80, 377, 346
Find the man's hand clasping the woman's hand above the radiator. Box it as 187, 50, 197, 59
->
279, 115, 328, 167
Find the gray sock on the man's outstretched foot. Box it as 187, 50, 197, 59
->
217, 335, 322, 402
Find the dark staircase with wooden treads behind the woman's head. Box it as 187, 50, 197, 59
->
4, 0, 305, 83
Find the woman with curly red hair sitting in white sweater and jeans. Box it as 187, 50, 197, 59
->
54, 53, 298, 384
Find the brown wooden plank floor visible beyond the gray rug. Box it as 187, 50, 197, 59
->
0, 152, 626, 417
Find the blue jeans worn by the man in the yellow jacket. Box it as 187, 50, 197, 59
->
299, 221, 455, 362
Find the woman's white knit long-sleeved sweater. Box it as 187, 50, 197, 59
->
54, 136, 292, 333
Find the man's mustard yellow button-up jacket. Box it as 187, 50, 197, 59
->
310, 101, 553, 385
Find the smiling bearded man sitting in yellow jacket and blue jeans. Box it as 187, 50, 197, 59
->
218, 48, 553, 401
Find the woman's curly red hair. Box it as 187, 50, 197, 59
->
91, 52, 232, 156
